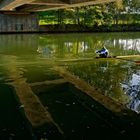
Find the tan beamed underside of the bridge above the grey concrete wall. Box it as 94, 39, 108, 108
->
0, 0, 116, 12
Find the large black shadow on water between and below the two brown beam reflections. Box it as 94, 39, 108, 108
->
32, 83, 140, 140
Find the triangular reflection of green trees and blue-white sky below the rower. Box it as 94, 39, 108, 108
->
66, 59, 140, 113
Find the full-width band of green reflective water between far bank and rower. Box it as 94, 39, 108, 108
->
0, 33, 140, 58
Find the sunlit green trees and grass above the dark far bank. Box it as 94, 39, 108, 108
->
38, 0, 140, 27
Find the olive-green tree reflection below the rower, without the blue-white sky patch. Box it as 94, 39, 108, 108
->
67, 60, 128, 104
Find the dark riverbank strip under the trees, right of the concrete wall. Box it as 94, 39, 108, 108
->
39, 24, 140, 33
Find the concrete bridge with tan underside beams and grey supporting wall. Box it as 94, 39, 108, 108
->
0, 0, 117, 33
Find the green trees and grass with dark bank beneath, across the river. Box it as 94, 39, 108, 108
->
38, 0, 140, 33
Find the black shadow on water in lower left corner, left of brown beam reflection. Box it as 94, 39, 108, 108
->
0, 84, 34, 140
